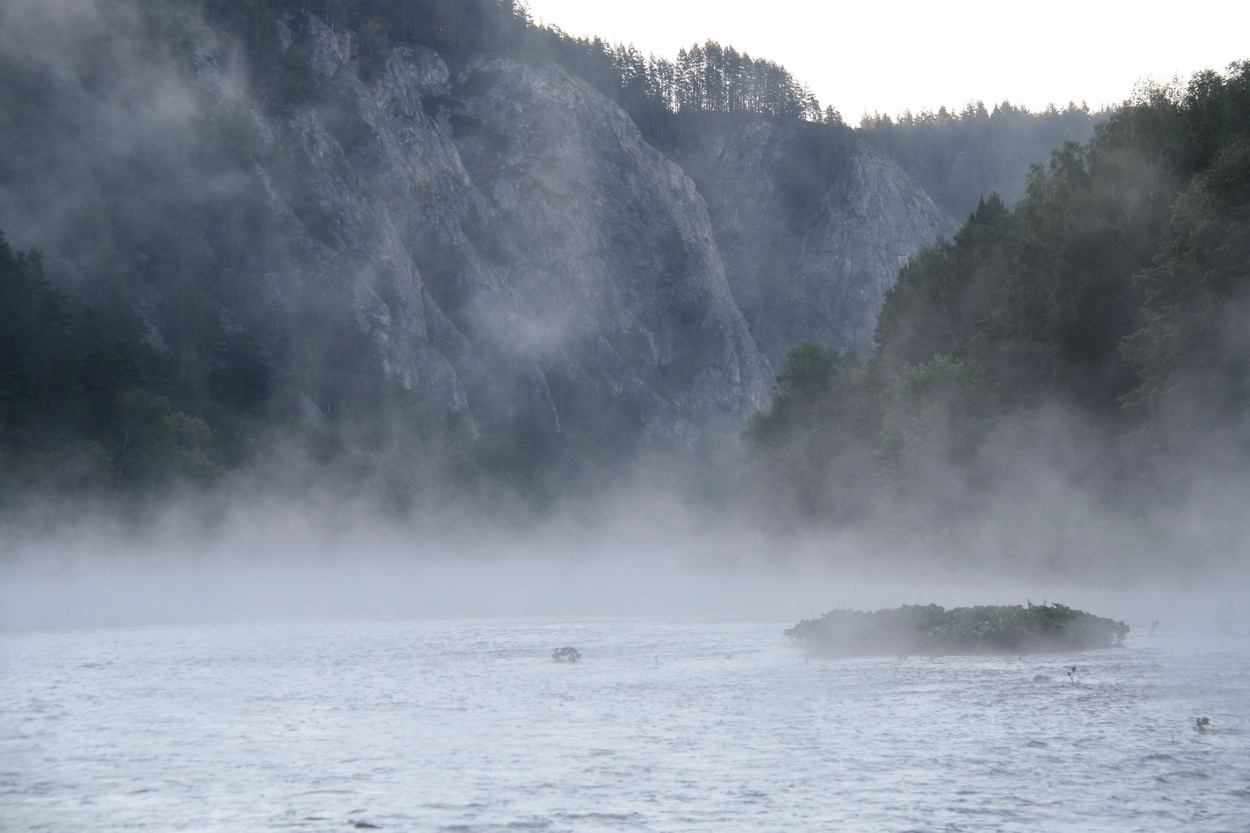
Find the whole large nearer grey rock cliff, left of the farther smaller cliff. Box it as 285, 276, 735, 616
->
203, 19, 771, 444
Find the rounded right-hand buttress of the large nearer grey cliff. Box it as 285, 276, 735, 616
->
440, 60, 771, 442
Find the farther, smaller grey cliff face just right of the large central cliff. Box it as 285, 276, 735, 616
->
676, 119, 956, 365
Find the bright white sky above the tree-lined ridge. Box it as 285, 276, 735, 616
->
529, 0, 1250, 124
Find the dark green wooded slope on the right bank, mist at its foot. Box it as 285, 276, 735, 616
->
746, 63, 1250, 558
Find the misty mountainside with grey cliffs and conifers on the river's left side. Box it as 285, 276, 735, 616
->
0, 0, 1120, 523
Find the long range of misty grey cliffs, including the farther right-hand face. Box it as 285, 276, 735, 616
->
0, 0, 949, 445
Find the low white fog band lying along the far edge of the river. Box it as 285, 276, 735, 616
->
0, 490, 1250, 633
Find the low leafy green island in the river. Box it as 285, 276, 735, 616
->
785, 603, 1129, 657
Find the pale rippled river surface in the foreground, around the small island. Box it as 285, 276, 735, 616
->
0, 619, 1250, 833
